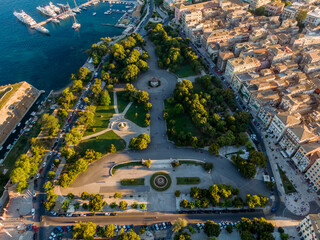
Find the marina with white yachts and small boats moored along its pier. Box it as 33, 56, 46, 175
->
13, 0, 136, 34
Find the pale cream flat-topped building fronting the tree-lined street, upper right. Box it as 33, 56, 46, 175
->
224, 57, 260, 83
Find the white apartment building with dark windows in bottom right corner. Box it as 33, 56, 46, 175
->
298, 214, 320, 240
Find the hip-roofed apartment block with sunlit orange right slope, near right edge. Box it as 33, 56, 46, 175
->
279, 124, 318, 157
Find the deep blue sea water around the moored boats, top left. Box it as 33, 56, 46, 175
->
0, 0, 127, 92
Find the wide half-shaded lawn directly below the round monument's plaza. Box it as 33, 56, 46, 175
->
78, 130, 126, 155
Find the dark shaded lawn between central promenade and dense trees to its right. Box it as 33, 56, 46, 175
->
164, 101, 202, 138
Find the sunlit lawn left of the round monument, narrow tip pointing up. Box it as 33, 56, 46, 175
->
84, 93, 115, 136
